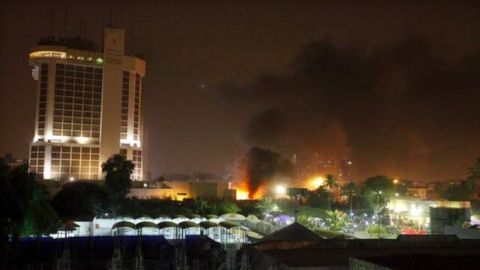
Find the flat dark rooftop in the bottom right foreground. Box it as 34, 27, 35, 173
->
249, 236, 480, 270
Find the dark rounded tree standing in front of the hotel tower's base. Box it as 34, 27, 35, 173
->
102, 154, 135, 204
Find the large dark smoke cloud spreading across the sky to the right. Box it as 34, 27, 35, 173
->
221, 37, 480, 180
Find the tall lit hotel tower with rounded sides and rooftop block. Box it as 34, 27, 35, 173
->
29, 28, 145, 181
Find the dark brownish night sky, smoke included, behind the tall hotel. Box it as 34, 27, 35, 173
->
0, 1, 480, 180
